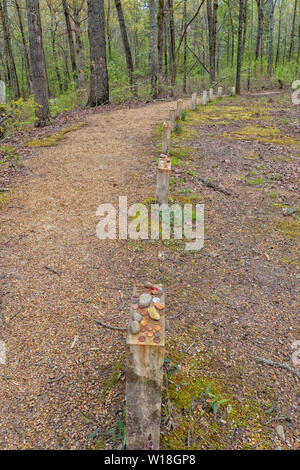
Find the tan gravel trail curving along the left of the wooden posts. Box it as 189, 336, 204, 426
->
0, 99, 177, 449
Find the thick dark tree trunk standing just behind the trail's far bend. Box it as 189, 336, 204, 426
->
87, 0, 109, 107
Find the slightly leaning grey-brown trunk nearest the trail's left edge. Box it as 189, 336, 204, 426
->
26, 0, 50, 127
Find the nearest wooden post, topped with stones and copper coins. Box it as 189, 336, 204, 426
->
126, 283, 165, 450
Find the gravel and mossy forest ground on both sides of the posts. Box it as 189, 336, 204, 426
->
0, 94, 300, 449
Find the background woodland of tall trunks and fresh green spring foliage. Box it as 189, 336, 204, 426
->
0, 0, 300, 125
